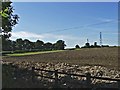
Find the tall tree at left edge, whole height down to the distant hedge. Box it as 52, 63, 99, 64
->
0, 2, 19, 50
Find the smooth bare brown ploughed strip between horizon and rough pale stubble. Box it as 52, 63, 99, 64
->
3, 47, 119, 67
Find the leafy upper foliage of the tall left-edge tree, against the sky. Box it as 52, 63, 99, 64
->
0, 2, 19, 38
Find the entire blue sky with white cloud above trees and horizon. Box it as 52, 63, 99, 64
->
10, 2, 118, 48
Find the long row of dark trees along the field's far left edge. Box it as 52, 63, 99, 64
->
2, 38, 66, 51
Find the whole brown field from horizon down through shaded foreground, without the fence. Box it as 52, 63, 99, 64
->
2, 48, 120, 88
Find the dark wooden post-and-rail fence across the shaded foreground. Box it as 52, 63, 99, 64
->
32, 67, 120, 90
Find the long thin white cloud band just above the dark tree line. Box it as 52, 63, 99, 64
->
11, 31, 82, 40
